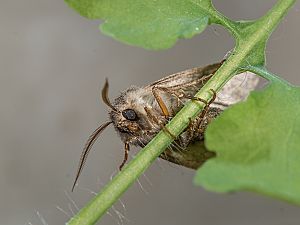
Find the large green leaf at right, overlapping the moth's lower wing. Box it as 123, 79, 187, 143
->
195, 82, 300, 205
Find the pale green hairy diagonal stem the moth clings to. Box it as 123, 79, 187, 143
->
67, 0, 295, 225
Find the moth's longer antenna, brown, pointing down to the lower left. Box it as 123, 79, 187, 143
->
72, 121, 112, 192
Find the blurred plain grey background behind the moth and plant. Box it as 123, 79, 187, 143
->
0, 0, 300, 225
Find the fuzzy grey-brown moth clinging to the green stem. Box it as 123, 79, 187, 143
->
72, 61, 259, 190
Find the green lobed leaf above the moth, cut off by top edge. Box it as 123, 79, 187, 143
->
65, 0, 216, 49
